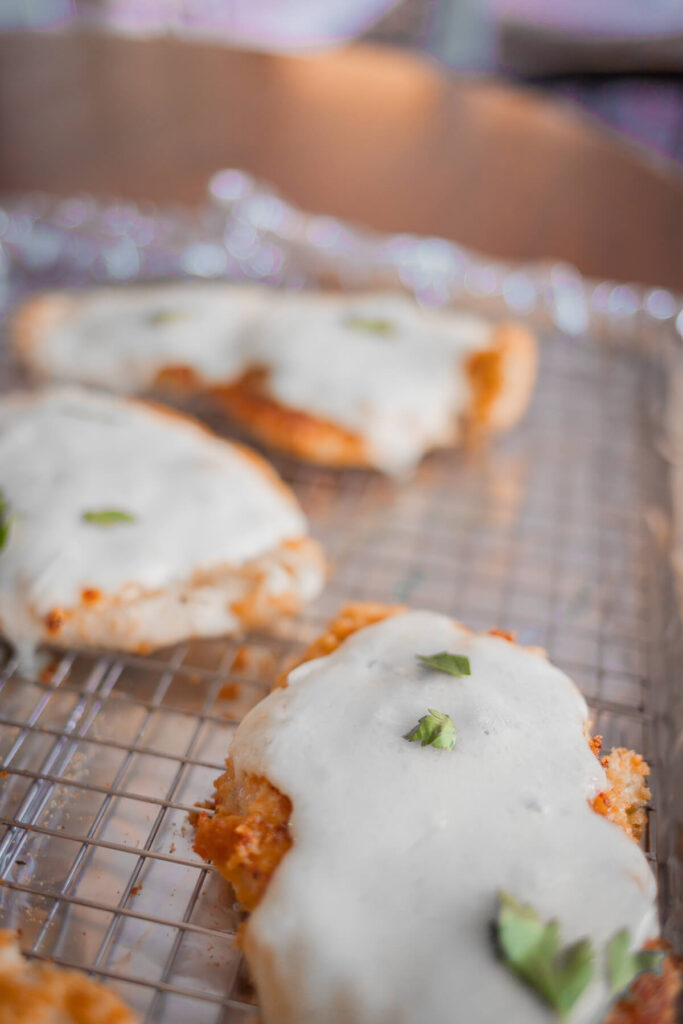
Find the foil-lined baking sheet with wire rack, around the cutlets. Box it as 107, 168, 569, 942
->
0, 178, 683, 1024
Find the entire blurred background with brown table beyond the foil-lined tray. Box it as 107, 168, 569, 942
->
0, 0, 683, 290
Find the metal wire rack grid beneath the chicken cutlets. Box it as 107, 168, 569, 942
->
0, 325, 666, 1024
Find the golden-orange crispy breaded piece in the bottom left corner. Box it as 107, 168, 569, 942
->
0, 931, 138, 1024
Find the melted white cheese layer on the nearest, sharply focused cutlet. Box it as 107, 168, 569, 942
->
231, 611, 657, 1024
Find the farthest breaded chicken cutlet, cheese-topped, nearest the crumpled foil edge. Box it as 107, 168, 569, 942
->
13, 284, 537, 473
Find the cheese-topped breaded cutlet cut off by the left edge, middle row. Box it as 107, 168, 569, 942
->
0, 388, 325, 652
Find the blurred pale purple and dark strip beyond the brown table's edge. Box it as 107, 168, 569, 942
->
0, 0, 683, 163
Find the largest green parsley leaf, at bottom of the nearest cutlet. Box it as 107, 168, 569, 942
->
497, 892, 595, 1017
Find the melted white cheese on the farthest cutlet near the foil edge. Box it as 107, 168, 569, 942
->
28, 285, 492, 472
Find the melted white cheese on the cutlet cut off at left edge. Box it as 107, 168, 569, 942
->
0, 388, 311, 642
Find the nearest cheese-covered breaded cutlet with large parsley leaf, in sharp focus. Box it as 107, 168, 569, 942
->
196, 605, 679, 1024
